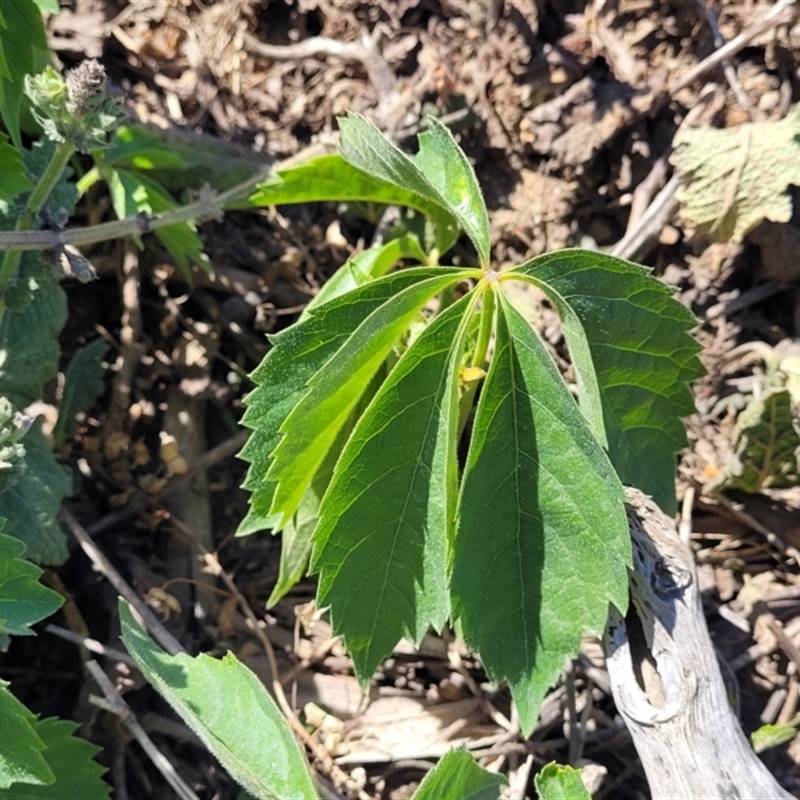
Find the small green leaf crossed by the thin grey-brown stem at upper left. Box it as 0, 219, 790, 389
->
105, 169, 211, 277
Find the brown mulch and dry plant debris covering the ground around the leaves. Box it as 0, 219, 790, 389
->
6, 0, 800, 800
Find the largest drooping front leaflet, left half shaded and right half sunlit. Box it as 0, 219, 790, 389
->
450, 291, 631, 735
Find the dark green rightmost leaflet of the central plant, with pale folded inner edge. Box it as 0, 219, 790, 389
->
507, 250, 703, 513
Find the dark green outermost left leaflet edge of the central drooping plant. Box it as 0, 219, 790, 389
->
239, 267, 476, 535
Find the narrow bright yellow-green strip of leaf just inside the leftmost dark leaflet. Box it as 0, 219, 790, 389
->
267, 267, 475, 523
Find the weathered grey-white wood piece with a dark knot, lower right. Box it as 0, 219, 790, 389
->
604, 489, 792, 800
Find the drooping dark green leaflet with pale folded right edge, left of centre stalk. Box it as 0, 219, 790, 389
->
312, 296, 475, 683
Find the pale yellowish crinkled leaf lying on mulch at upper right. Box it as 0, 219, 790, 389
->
670, 105, 800, 242
